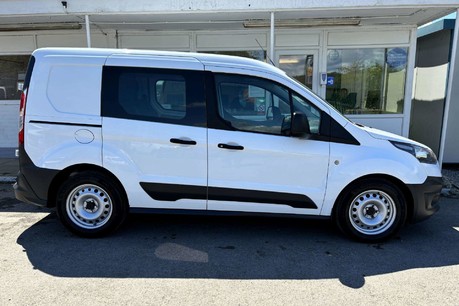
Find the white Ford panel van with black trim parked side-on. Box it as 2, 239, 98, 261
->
15, 48, 442, 241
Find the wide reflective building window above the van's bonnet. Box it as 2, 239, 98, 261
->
326, 48, 408, 114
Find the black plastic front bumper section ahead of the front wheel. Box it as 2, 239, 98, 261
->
407, 176, 443, 223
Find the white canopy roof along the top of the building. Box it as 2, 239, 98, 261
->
0, 0, 459, 31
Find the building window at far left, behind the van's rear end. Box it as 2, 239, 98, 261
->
0, 55, 30, 100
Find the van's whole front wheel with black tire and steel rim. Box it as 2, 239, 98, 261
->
334, 179, 407, 243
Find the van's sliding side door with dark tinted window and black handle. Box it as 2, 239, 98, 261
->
102, 55, 207, 209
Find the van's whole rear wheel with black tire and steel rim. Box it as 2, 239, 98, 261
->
56, 171, 128, 238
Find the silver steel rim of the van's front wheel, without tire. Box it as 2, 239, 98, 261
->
349, 190, 397, 235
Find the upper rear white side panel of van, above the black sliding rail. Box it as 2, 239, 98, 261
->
26, 55, 106, 120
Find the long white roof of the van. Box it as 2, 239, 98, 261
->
32, 48, 285, 75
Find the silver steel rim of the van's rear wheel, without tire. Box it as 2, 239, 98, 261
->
66, 184, 113, 229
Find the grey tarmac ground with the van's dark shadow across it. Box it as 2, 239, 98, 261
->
0, 184, 459, 305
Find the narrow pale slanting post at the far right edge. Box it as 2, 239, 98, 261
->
438, 9, 459, 167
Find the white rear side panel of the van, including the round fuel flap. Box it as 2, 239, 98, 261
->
25, 55, 106, 170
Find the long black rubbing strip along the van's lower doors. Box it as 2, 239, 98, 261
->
140, 182, 317, 209
